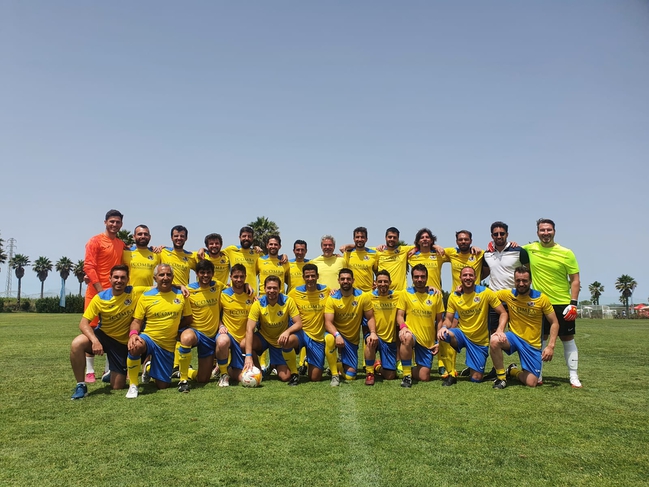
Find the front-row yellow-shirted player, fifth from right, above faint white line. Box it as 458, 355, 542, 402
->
324, 268, 378, 387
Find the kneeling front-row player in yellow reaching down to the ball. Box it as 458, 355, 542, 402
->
241, 276, 302, 386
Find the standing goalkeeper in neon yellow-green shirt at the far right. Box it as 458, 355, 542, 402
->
523, 218, 581, 389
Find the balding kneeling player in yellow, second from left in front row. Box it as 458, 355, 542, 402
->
126, 264, 192, 399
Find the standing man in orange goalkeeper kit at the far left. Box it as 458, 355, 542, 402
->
83, 210, 126, 382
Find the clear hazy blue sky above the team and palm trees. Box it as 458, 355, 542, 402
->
0, 0, 649, 303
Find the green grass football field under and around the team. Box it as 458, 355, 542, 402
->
0, 313, 649, 486
